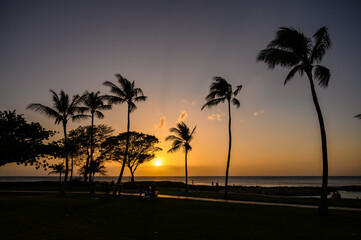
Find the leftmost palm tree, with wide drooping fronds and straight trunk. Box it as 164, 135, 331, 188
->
26, 90, 88, 194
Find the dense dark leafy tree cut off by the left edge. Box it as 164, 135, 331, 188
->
0, 110, 55, 169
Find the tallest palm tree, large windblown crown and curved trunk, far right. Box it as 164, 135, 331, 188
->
257, 27, 332, 213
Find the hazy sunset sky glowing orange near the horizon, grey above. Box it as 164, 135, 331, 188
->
0, 0, 361, 176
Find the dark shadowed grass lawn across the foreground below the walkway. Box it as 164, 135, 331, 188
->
0, 193, 361, 240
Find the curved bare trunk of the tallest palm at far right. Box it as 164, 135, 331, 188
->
307, 71, 328, 213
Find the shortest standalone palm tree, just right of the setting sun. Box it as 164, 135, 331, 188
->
165, 122, 197, 193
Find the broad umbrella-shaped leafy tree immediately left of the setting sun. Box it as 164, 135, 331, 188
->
100, 131, 162, 182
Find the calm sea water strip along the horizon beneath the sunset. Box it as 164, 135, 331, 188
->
0, 176, 361, 187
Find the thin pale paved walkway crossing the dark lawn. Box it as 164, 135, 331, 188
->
0, 190, 361, 212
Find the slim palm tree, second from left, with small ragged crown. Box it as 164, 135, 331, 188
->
83, 91, 112, 189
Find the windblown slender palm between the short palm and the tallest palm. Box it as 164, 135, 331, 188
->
202, 77, 242, 197
